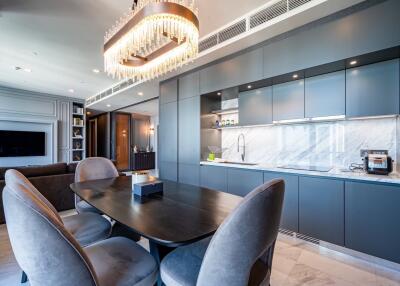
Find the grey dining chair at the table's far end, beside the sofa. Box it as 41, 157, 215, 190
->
75, 157, 119, 213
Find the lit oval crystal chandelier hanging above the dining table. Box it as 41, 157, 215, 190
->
104, 0, 199, 81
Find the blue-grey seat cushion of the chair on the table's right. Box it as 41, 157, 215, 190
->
160, 237, 212, 286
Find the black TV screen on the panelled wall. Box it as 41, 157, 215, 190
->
0, 130, 46, 157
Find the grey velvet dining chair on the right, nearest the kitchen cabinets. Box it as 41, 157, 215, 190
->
160, 180, 285, 286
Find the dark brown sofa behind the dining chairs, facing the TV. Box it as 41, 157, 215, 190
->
0, 163, 77, 224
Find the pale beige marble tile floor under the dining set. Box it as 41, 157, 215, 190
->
0, 214, 400, 286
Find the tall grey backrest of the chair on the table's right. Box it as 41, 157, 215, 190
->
197, 180, 285, 286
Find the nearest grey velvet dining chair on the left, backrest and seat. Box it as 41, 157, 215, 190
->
3, 171, 158, 286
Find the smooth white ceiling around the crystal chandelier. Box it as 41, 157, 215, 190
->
0, 0, 269, 98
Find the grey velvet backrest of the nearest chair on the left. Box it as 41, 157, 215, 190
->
3, 170, 98, 286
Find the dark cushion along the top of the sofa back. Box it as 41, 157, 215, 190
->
0, 163, 67, 180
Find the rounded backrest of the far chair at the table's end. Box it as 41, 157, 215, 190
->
75, 157, 119, 183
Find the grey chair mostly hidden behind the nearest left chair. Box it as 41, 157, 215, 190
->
5, 170, 111, 283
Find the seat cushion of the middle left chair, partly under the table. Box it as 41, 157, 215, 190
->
62, 213, 111, 247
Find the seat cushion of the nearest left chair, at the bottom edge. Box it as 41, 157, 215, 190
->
84, 237, 158, 286
